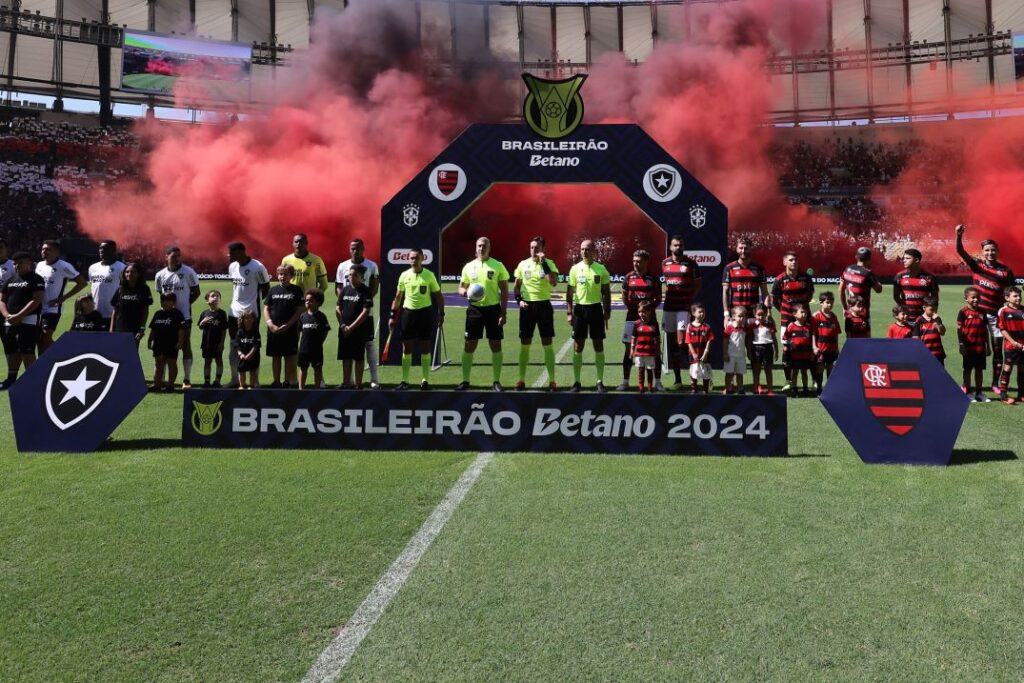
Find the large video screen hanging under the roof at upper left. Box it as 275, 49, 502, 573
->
121, 30, 252, 100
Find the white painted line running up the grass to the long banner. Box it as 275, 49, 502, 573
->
302, 453, 495, 683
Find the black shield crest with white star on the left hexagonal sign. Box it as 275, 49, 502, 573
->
45, 353, 119, 431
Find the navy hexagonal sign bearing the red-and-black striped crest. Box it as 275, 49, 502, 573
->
821, 339, 971, 465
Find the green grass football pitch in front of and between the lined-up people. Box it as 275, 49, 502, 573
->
0, 282, 1024, 682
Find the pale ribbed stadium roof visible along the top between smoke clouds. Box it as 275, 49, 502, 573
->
0, 0, 1024, 122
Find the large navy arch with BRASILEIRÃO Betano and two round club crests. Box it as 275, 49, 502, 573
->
378, 124, 728, 367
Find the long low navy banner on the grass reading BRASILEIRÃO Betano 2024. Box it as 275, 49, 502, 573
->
181, 389, 788, 456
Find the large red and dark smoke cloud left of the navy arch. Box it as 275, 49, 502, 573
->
75, 2, 514, 272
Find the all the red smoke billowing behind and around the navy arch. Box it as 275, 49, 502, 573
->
76, 0, 1024, 280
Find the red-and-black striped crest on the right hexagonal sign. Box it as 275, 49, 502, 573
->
860, 362, 925, 436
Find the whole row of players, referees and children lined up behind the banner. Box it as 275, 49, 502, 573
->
0, 226, 1016, 395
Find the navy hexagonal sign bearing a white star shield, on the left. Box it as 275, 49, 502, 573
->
8, 332, 145, 453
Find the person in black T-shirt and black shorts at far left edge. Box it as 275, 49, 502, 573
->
0, 252, 46, 389
